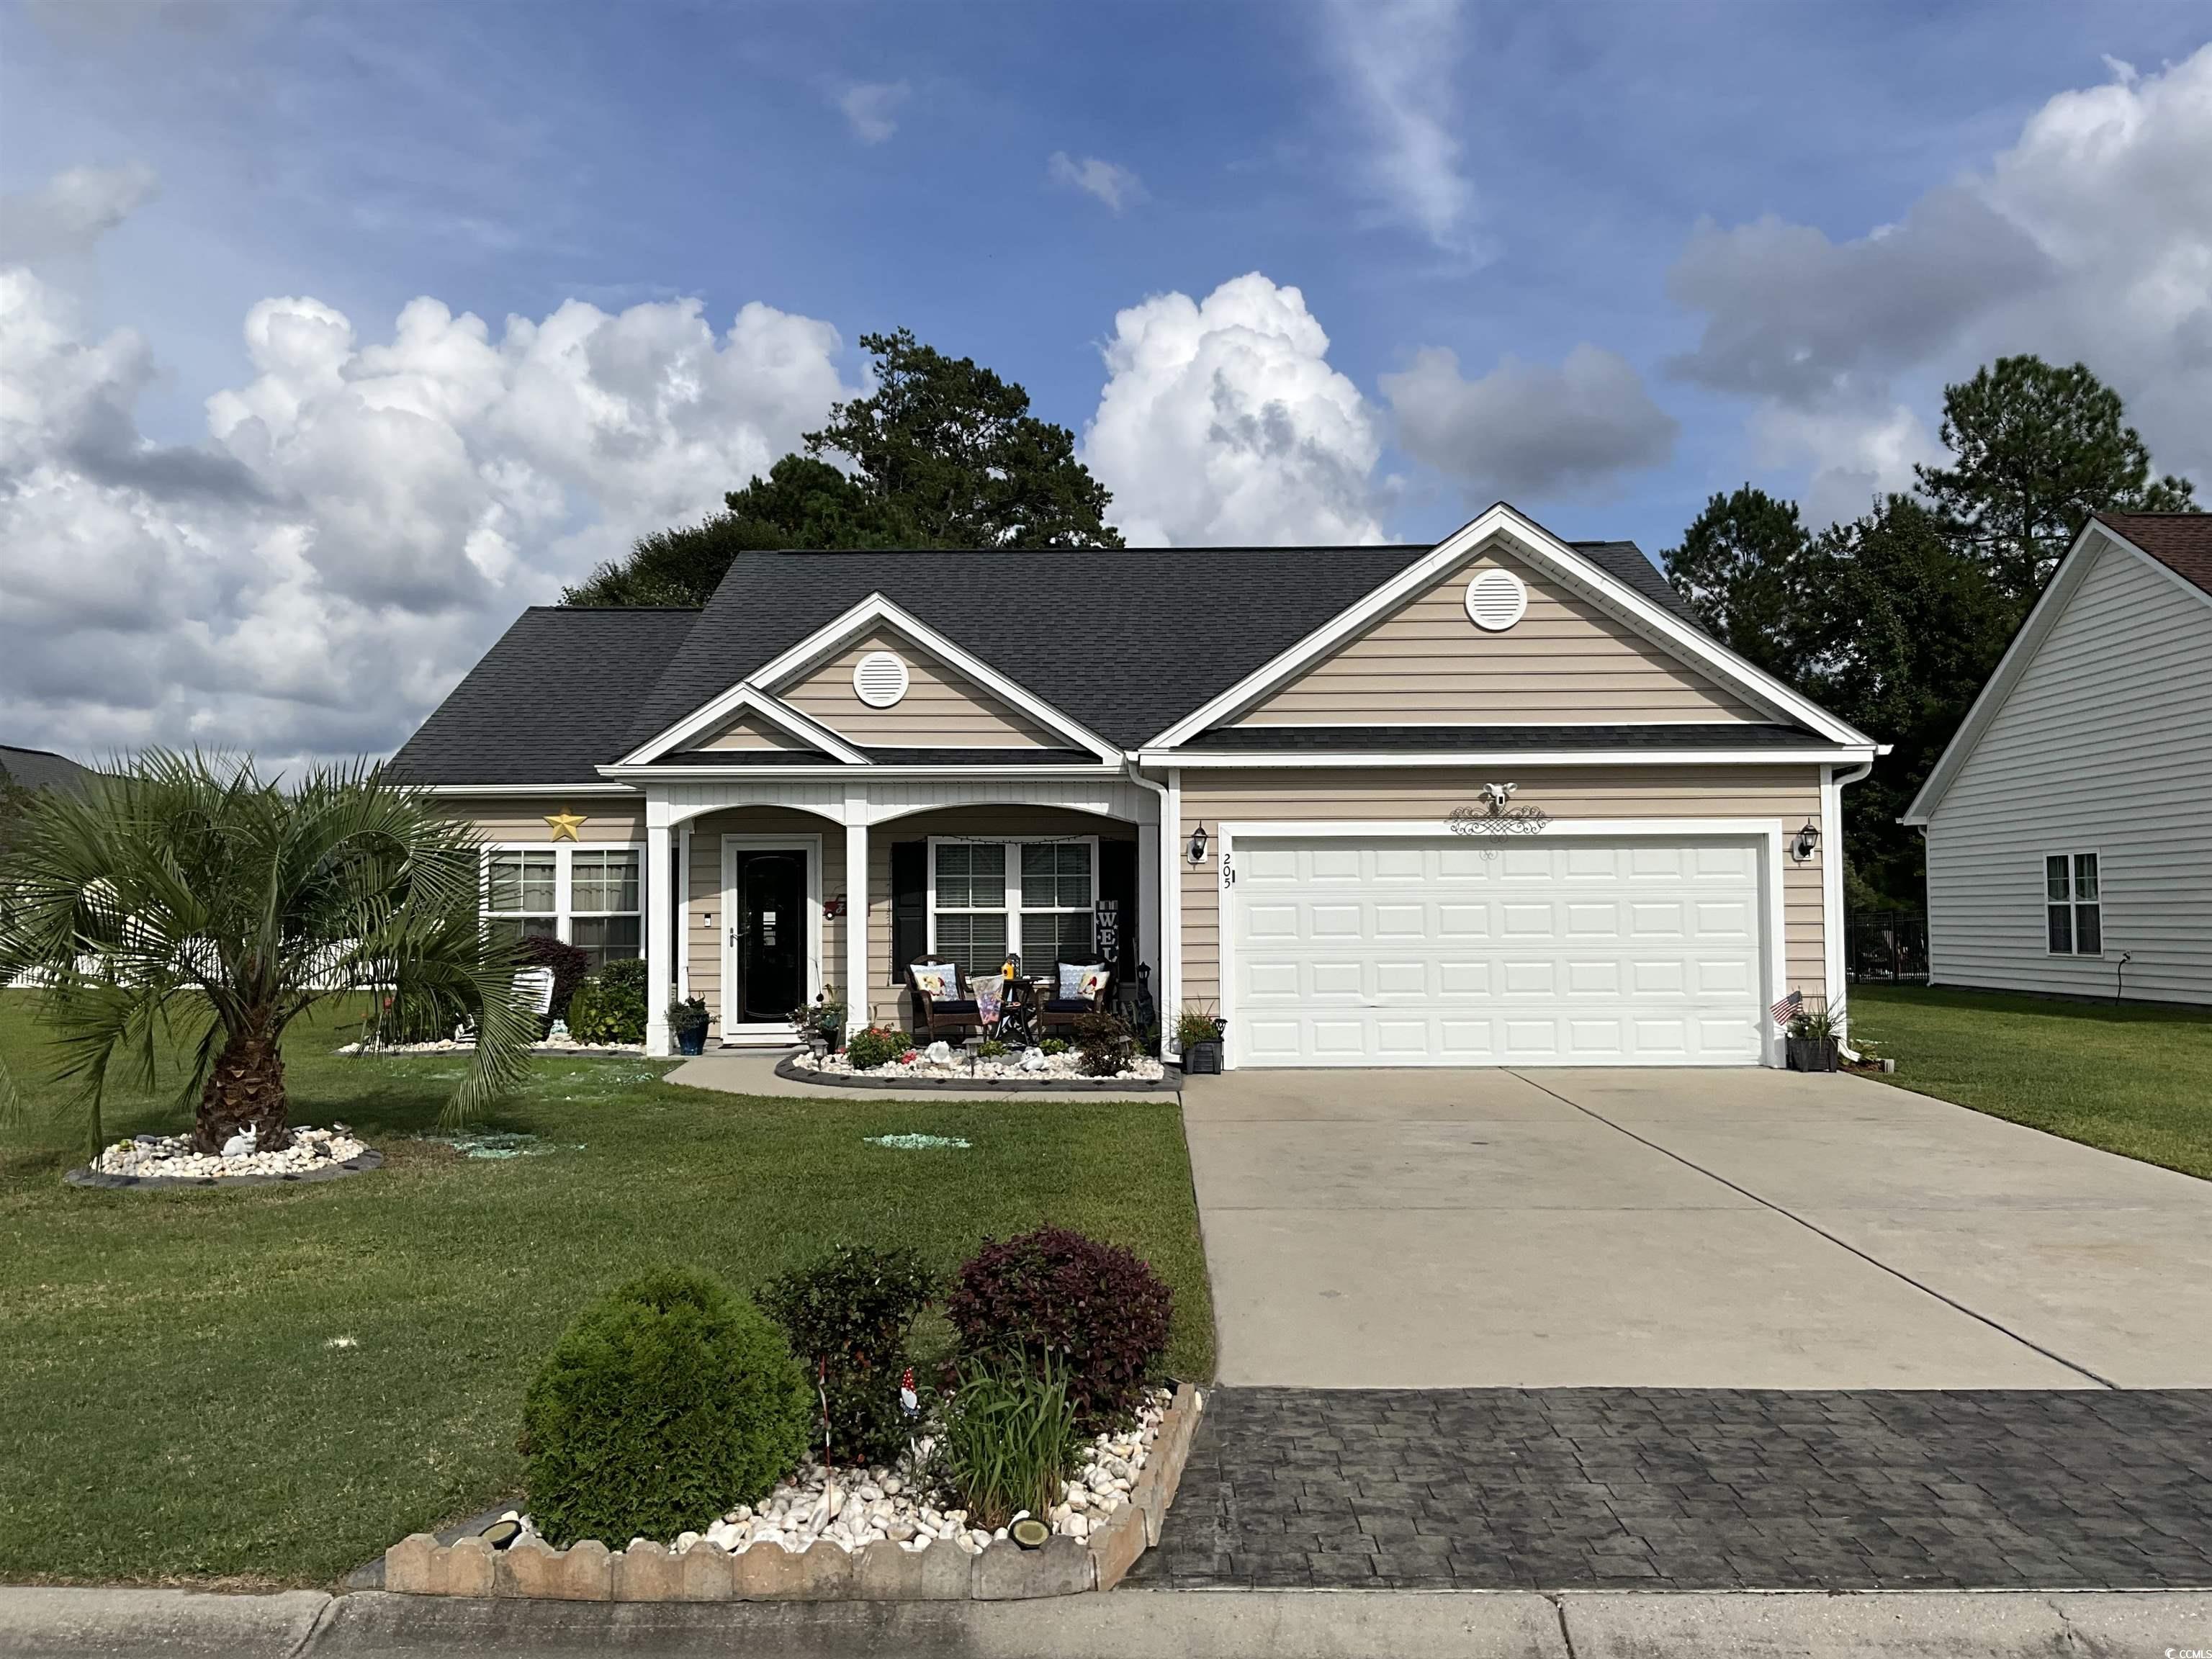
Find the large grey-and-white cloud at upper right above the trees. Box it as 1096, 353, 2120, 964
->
1668, 47, 2212, 511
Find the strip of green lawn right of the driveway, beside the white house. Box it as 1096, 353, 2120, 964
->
1851, 984, 2212, 1181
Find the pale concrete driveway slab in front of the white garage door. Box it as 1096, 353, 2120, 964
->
1184, 1071, 2212, 1389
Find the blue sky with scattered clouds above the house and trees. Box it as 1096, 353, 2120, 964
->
0, 4, 2212, 752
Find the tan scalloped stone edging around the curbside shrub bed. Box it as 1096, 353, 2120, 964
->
385, 1382, 1203, 1601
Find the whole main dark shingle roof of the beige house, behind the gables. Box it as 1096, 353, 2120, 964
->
392, 542, 1694, 783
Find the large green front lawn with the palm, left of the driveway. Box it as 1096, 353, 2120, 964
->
0, 991, 1215, 1584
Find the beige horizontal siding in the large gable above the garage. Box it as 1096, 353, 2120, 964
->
1236, 553, 1768, 726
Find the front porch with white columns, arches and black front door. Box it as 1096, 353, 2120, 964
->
646, 774, 1166, 1055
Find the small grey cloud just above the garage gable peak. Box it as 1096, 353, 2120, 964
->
1380, 343, 1677, 504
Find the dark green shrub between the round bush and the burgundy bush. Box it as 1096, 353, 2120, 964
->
761, 1246, 938, 1465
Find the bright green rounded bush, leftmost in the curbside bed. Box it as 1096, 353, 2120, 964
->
522, 1267, 814, 1548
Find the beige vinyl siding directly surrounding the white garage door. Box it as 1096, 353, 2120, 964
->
1177, 765, 1827, 1009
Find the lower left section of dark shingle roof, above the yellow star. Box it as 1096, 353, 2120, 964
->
387, 604, 699, 783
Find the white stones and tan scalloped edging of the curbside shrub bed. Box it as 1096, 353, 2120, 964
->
385, 1382, 1201, 1601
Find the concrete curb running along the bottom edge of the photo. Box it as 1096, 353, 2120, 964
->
0, 1588, 2212, 1659
